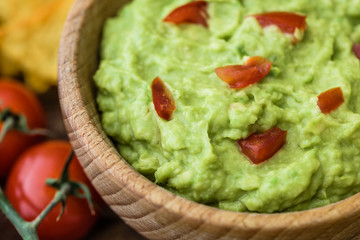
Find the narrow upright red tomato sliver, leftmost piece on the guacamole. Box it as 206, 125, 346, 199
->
151, 77, 176, 121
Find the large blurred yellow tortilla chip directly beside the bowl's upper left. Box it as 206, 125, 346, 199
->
0, 0, 74, 92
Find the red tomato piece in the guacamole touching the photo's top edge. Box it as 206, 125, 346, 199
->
164, 1, 209, 28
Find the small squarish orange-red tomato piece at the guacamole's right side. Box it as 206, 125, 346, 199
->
318, 87, 345, 114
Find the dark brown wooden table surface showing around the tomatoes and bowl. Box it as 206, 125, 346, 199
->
0, 88, 145, 240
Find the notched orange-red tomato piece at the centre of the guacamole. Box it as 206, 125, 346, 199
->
215, 57, 272, 89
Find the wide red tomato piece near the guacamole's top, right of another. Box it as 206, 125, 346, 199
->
253, 12, 306, 42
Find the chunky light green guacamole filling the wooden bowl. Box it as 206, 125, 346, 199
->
94, 0, 360, 213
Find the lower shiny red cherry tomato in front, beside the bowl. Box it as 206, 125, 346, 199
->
5, 141, 97, 240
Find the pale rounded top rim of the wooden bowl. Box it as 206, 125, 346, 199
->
58, 0, 360, 234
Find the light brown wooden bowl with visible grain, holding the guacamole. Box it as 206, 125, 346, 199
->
59, 0, 360, 240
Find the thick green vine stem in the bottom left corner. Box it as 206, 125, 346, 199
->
0, 188, 39, 240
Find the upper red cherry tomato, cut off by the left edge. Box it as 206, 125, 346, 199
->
0, 79, 46, 178
